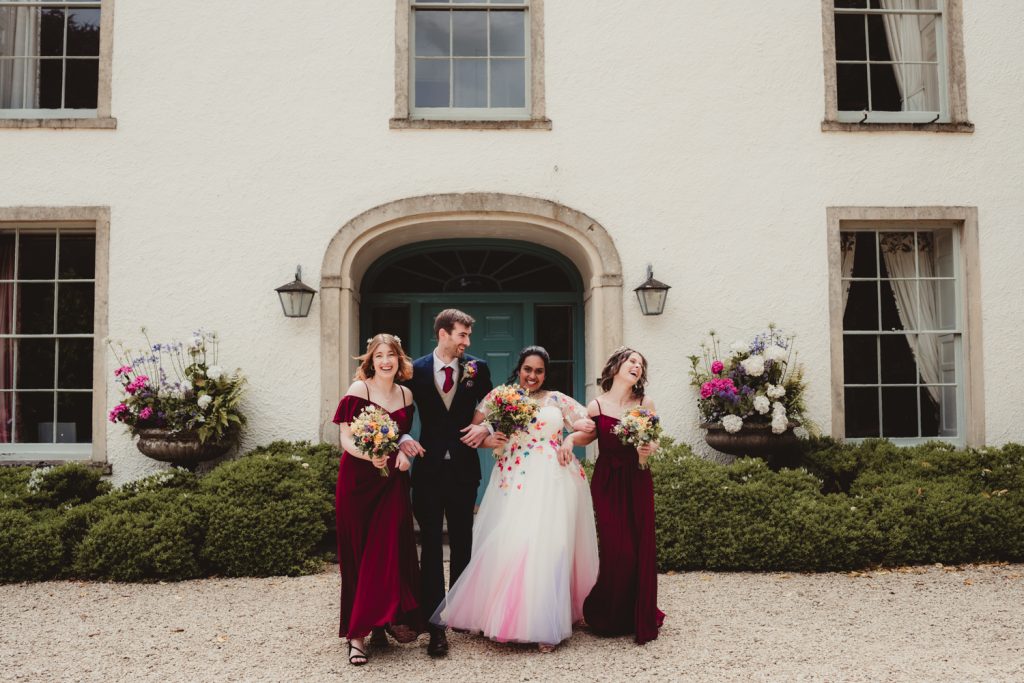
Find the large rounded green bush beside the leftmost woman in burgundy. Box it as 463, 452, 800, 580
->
200, 455, 332, 577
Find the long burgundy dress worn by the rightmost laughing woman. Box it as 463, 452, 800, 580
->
583, 404, 665, 645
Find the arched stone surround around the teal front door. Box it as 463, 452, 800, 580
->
321, 193, 623, 442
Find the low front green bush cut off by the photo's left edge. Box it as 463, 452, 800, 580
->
0, 509, 62, 583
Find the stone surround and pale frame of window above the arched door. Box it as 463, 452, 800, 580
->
390, 0, 551, 130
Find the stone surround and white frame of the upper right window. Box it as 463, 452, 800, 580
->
821, 0, 974, 133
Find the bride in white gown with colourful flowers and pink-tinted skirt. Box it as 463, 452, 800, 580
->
430, 346, 598, 652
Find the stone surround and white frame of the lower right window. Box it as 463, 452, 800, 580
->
827, 207, 985, 446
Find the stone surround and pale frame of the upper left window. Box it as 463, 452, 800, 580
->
0, 0, 117, 128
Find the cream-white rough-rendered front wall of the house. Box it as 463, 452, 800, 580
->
0, 0, 1024, 480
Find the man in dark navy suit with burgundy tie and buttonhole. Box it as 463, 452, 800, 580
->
399, 308, 492, 657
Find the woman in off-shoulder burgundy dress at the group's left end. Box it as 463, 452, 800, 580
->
334, 334, 425, 666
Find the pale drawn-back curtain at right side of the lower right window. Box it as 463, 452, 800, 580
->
881, 232, 942, 403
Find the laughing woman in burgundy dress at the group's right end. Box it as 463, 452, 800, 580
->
580, 347, 665, 645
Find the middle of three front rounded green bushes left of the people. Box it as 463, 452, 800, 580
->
72, 488, 207, 581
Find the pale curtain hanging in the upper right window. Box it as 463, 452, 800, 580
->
881, 0, 938, 112
